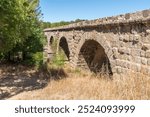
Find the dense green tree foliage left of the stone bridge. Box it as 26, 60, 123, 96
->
0, 0, 43, 66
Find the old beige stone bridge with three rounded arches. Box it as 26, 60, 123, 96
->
44, 10, 150, 76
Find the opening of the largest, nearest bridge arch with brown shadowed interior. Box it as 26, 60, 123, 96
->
77, 40, 112, 75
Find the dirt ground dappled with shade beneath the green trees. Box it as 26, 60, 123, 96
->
0, 65, 47, 99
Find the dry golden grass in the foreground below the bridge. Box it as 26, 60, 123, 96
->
10, 65, 150, 100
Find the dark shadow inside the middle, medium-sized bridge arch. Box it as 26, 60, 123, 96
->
59, 37, 70, 61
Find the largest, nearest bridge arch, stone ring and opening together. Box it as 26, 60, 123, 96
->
76, 34, 113, 75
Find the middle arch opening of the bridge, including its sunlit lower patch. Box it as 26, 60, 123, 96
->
58, 37, 70, 61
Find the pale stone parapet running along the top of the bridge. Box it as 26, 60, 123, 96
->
44, 9, 150, 32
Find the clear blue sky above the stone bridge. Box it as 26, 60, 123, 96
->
40, 0, 150, 22
